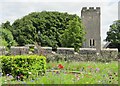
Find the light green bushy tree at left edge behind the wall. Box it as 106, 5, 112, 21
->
0, 27, 17, 48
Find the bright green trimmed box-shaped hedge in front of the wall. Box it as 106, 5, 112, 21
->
0, 55, 46, 80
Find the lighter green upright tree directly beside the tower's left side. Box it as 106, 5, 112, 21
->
61, 18, 85, 52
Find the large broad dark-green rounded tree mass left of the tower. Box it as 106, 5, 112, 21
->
11, 11, 83, 48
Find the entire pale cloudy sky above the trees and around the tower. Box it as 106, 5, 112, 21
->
0, 0, 120, 44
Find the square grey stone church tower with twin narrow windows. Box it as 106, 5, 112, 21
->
81, 7, 101, 53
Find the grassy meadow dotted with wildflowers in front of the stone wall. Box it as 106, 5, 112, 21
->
0, 61, 118, 84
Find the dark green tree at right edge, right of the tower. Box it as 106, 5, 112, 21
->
105, 20, 120, 52
